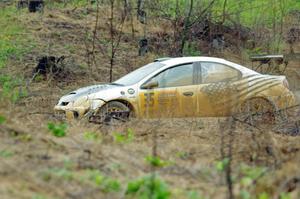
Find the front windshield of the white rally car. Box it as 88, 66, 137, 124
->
113, 62, 165, 86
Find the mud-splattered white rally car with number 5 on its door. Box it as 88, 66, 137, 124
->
54, 57, 295, 122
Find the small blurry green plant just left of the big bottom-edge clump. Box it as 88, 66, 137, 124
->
89, 170, 121, 193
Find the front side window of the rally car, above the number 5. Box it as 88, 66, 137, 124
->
149, 64, 193, 88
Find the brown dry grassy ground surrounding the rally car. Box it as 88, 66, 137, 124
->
0, 3, 300, 199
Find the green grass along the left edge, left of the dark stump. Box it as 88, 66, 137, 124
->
0, 6, 34, 102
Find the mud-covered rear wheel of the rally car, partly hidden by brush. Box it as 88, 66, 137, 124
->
241, 97, 276, 126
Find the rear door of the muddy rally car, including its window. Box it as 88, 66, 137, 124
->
198, 62, 242, 116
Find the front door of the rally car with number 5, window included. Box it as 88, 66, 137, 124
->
139, 63, 197, 118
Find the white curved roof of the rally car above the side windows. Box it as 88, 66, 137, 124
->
159, 57, 258, 74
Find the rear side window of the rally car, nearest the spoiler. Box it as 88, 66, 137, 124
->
201, 62, 241, 84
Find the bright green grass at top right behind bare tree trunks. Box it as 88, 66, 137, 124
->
160, 0, 300, 27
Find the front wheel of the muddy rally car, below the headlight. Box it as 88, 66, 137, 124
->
89, 101, 130, 124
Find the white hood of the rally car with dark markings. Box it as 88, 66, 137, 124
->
59, 84, 122, 104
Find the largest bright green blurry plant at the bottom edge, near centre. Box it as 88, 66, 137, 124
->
126, 176, 171, 199
